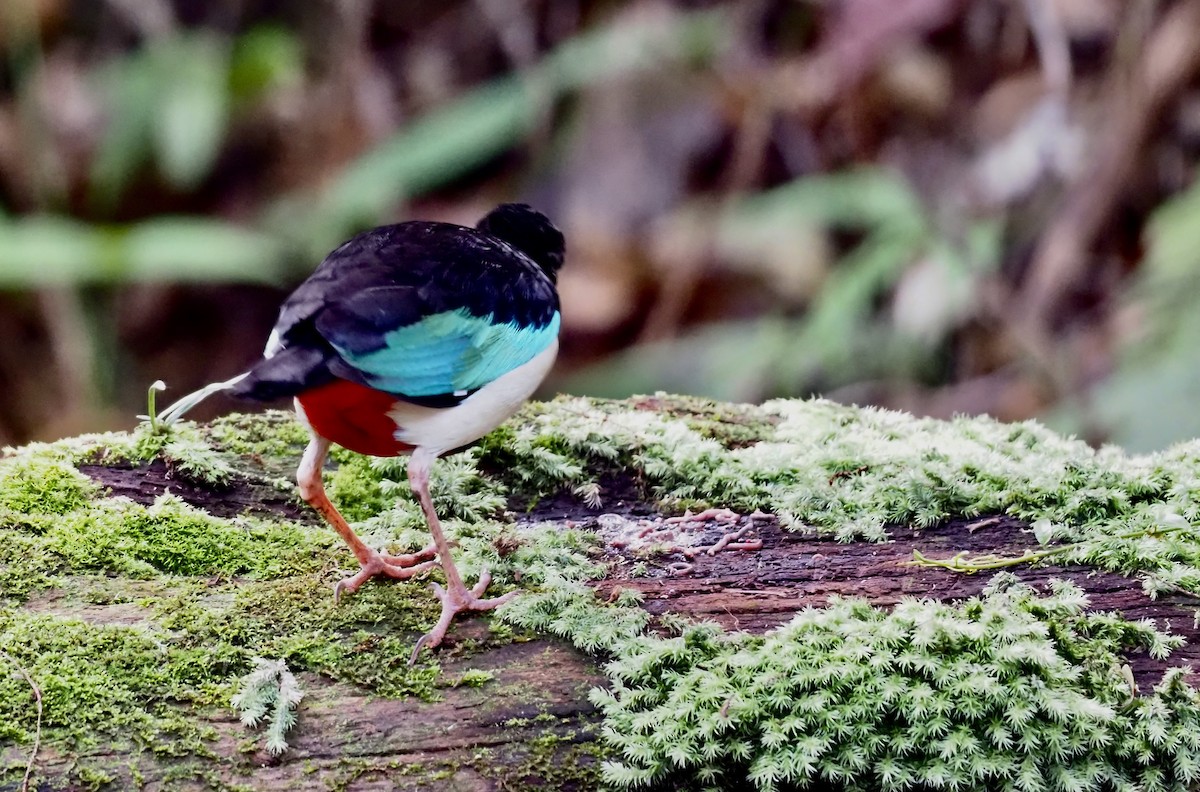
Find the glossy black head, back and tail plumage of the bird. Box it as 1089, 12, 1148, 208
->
232, 204, 563, 406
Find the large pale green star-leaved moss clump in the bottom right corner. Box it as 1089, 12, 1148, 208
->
593, 576, 1200, 792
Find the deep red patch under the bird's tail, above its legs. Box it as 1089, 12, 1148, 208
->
296, 379, 413, 456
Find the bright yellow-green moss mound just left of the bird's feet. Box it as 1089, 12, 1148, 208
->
47, 494, 330, 577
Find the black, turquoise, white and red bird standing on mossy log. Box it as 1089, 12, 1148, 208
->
160, 204, 565, 660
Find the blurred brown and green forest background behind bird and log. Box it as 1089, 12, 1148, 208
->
0, 0, 1200, 450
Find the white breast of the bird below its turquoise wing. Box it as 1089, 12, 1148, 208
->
388, 338, 558, 455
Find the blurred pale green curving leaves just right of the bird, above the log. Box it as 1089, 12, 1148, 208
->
569, 168, 1001, 401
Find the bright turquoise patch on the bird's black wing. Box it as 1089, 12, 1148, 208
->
334, 310, 559, 396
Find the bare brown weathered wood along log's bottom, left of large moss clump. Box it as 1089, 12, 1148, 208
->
8, 628, 601, 791
